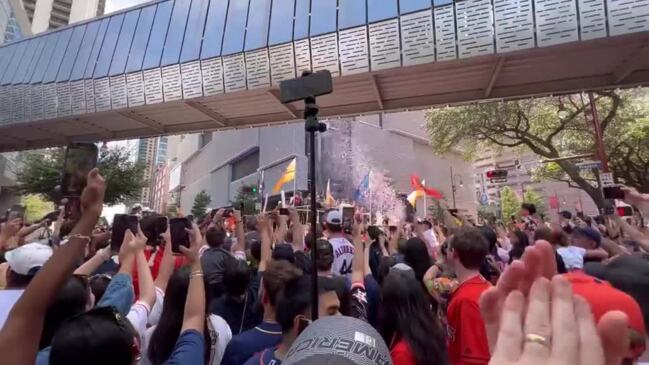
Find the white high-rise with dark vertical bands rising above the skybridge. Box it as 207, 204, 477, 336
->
22, 0, 106, 34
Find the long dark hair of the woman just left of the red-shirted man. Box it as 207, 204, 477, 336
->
379, 271, 447, 365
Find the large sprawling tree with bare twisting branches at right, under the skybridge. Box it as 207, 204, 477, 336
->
426, 90, 649, 207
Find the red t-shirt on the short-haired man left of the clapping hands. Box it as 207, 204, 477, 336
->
447, 275, 491, 365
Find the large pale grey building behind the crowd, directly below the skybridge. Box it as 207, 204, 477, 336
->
169, 111, 476, 220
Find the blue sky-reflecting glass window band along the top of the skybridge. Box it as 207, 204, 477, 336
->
0, 0, 452, 76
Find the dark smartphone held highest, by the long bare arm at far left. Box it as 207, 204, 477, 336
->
61, 143, 98, 197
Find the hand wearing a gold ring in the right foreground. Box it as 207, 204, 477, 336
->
489, 276, 628, 365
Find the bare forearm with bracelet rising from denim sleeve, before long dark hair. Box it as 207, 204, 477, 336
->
180, 224, 205, 334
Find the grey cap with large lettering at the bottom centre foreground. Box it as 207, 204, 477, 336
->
282, 316, 392, 365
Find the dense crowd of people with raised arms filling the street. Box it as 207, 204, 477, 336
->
0, 169, 649, 365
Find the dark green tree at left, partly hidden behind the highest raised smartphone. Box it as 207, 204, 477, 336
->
16, 147, 147, 205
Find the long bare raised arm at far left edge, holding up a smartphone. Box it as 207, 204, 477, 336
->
0, 169, 106, 364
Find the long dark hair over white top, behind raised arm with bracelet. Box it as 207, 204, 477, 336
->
146, 266, 211, 365
